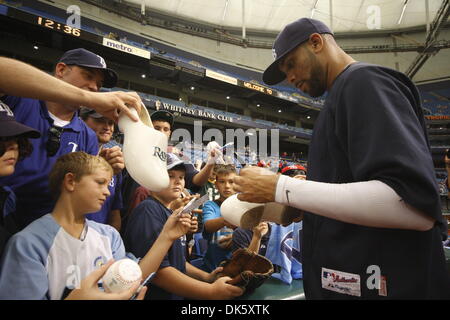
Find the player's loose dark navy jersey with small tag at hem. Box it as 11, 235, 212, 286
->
301, 63, 450, 299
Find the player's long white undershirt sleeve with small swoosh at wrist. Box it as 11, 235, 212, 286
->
275, 175, 434, 231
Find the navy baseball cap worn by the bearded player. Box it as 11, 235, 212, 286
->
263, 18, 333, 85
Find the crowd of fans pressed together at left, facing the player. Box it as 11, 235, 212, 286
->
0, 49, 306, 299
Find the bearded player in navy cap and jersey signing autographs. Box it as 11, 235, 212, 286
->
235, 18, 450, 299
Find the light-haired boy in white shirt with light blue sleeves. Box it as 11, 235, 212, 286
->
0, 152, 191, 300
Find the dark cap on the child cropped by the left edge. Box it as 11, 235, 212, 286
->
0, 101, 41, 138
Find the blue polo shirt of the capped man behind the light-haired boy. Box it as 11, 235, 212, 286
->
0, 96, 98, 229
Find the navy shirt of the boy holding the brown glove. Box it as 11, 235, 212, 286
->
123, 197, 186, 300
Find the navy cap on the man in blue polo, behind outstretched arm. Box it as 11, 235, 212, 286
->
58, 48, 118, 88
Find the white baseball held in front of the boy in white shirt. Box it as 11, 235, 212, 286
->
102, 258, 142, 292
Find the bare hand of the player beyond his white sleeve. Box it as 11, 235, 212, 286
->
234, 167, 278, 203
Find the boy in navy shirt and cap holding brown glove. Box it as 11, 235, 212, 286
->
124, 153, 242, 300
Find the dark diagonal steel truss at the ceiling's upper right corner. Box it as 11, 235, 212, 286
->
405, 0, 450, 79
